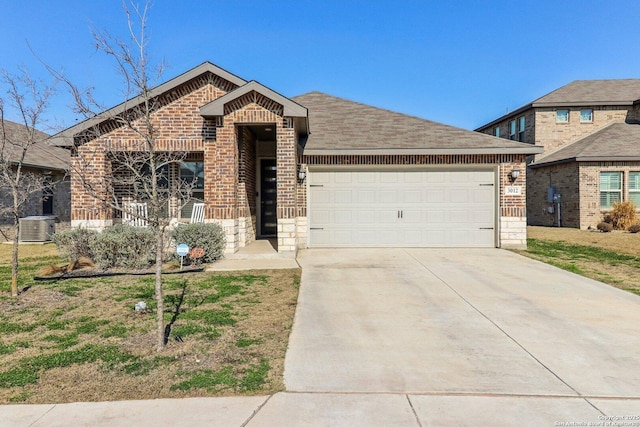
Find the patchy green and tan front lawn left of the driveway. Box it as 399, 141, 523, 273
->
0, 258, 300, 403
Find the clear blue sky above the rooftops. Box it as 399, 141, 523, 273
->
0, 0, 640, 133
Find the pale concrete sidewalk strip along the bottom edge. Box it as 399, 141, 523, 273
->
0, 392, 640, 427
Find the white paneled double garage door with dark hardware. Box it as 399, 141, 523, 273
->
308, 170, 495, 247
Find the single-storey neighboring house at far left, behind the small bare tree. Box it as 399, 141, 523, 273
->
0, 120, 71, 224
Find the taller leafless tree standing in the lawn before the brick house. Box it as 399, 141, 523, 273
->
58, 2, 196, 351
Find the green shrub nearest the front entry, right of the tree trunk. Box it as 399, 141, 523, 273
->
171, 223, 227, 262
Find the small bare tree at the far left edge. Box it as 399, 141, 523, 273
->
0, 68, 55, 296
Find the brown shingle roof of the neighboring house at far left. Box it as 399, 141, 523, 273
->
0, 120, 71, 171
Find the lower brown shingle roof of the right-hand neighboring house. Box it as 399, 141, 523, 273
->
530, 123, 640, 168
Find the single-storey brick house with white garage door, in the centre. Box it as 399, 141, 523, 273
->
57, 62, 541, 253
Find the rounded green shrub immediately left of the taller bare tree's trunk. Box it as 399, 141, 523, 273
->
90, 225, 156, 268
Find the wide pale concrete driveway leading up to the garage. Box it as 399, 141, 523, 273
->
285, 249, 640, 425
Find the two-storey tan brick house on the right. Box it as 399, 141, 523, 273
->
476, 79, 640, 229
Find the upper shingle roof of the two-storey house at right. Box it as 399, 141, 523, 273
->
476, 79, 640, 131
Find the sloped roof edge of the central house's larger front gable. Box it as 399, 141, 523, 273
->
51, 61, 247, 147
